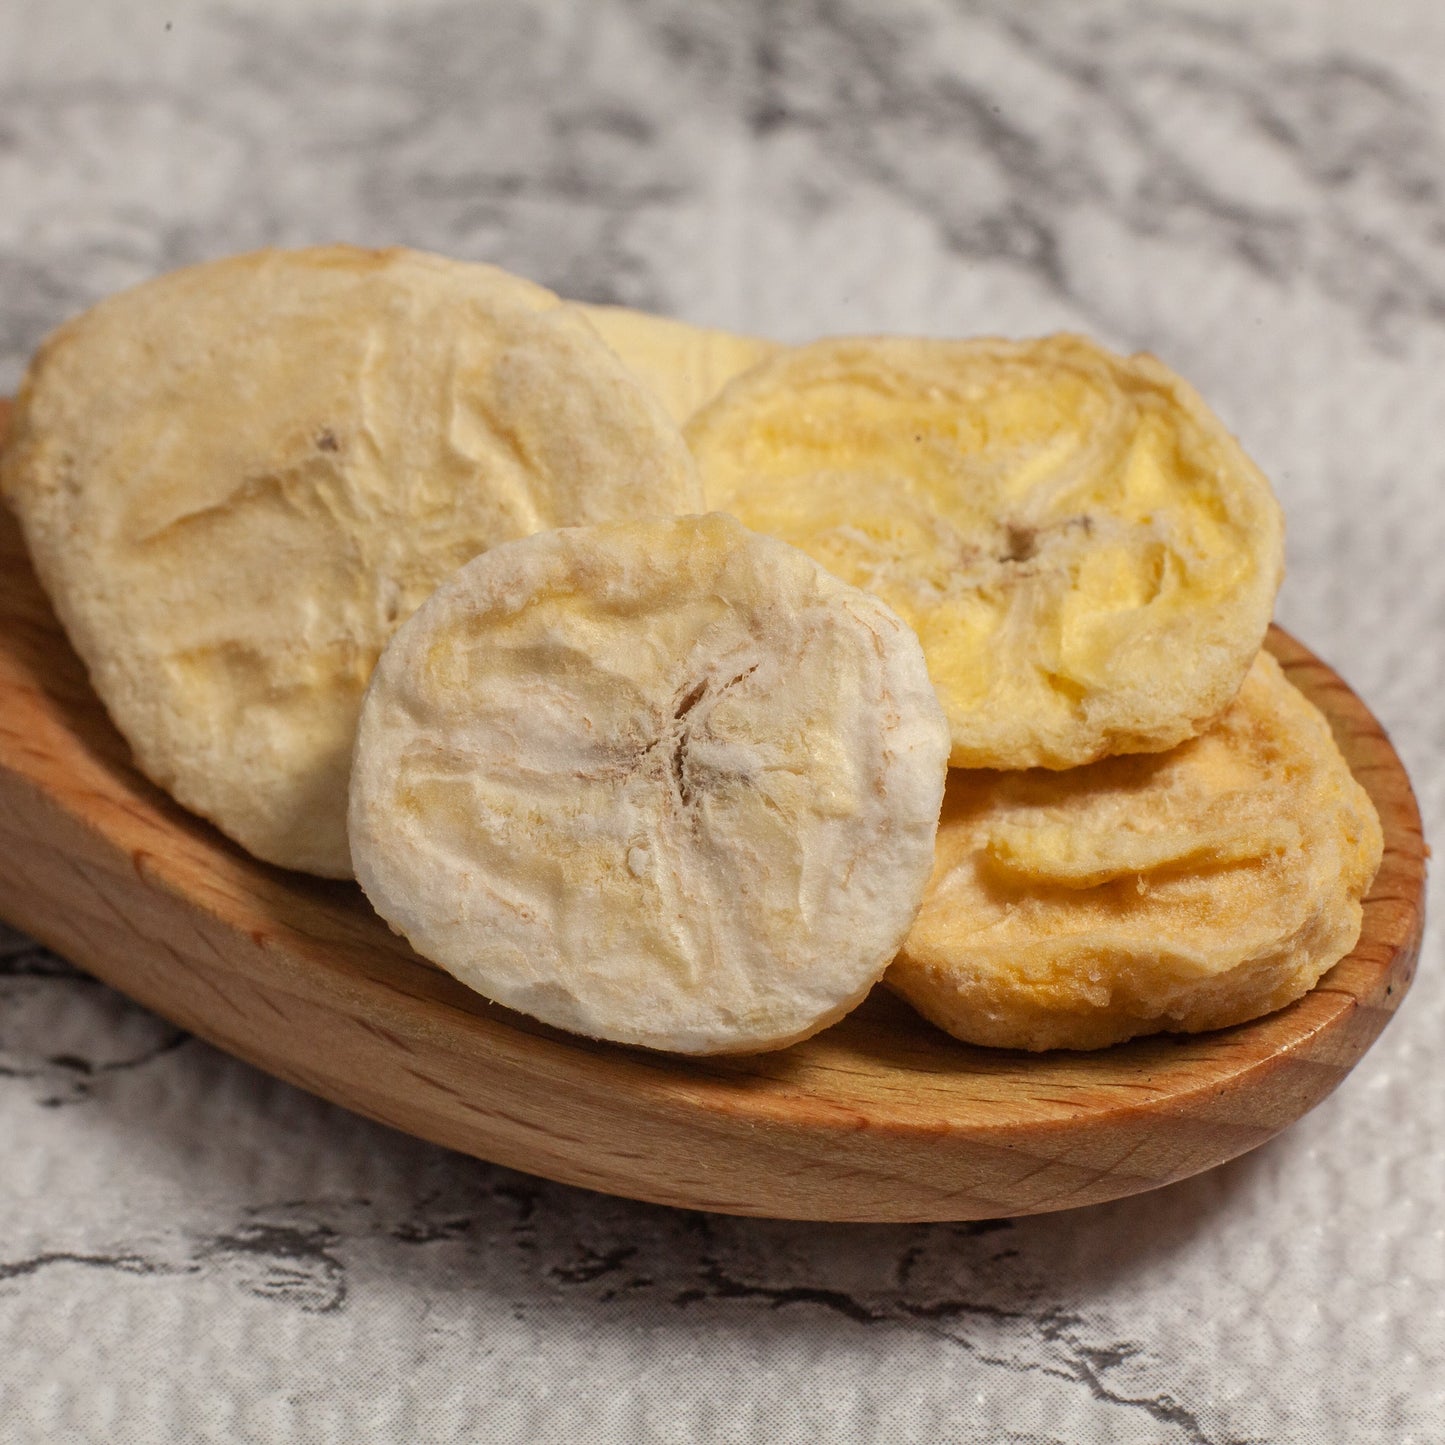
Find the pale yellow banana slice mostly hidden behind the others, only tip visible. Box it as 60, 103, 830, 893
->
579, 305, 780, 423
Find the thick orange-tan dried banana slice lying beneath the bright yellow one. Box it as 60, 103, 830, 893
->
887, 653, 1383, 1049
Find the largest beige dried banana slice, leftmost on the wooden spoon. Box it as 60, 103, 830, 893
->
0, 246, 701, 877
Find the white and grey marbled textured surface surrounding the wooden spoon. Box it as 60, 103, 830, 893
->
0, 0, 1445, 1445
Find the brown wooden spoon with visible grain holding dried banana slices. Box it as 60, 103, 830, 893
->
0, 403, 1425, 1221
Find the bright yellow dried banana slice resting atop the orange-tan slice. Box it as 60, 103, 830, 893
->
686, 337, 1283, 767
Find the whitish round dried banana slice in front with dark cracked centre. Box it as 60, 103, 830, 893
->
351, 516, 948, 1053
